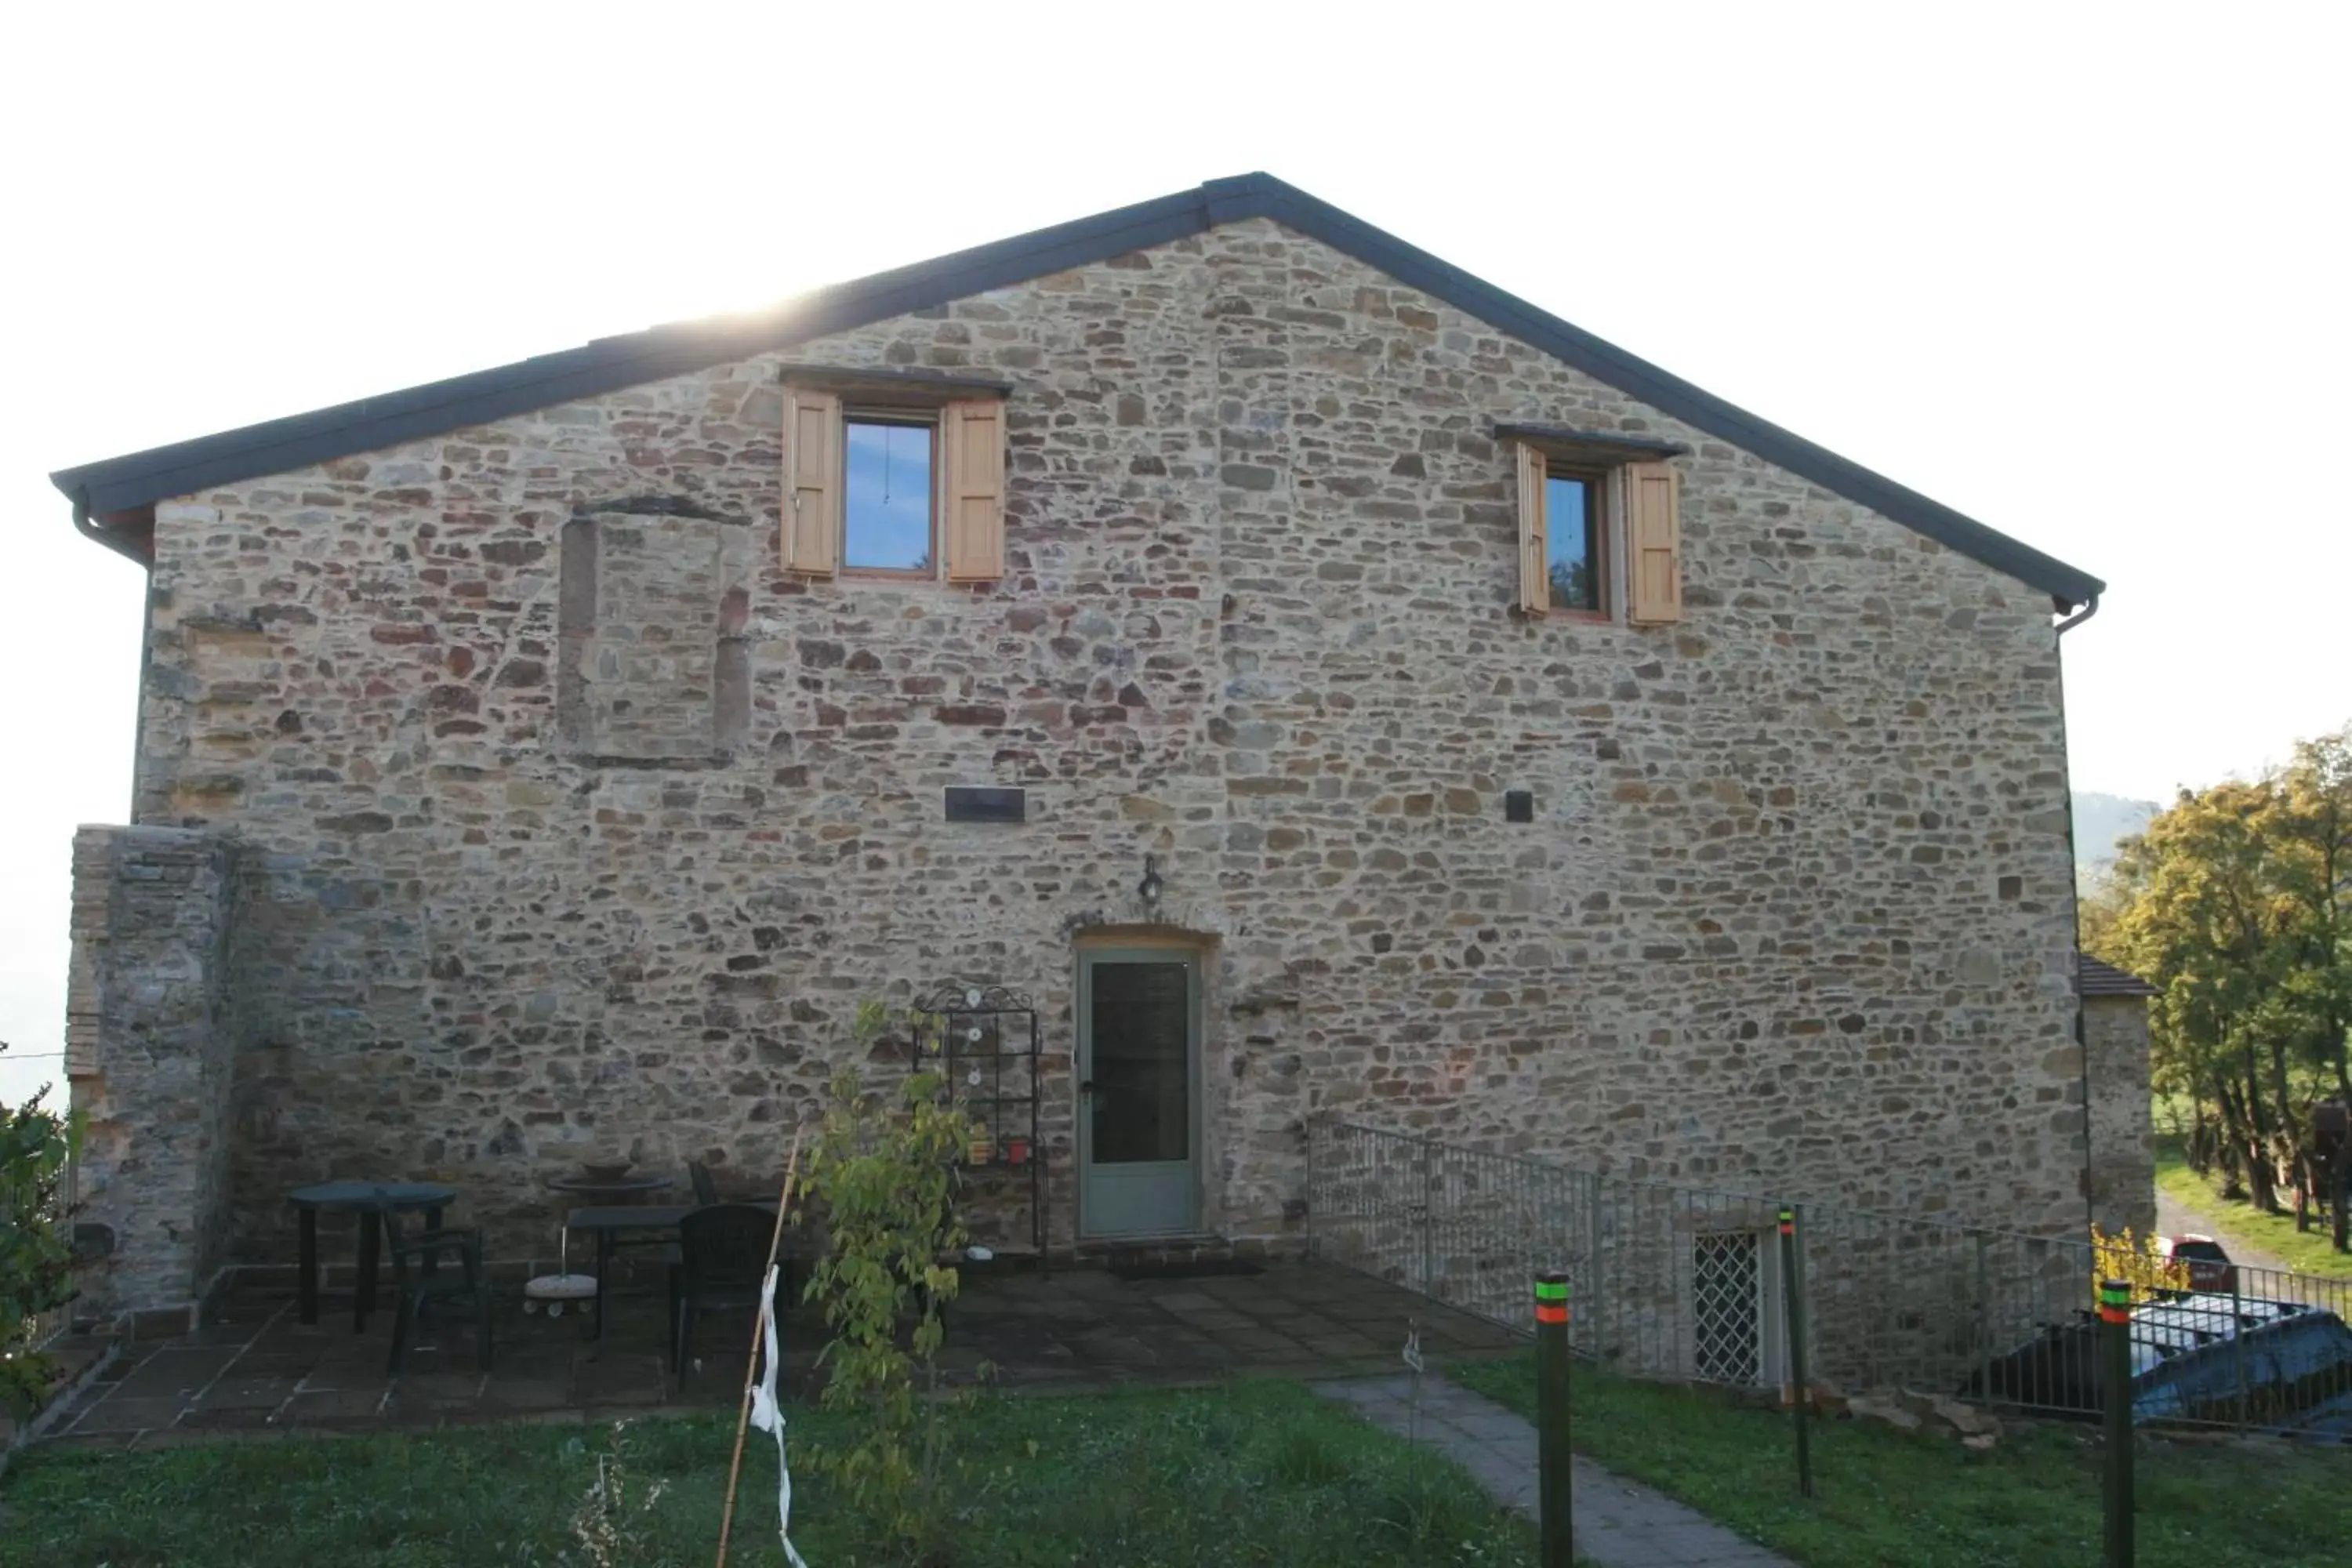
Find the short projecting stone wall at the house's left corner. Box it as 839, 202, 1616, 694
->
66, 827, 238, 1326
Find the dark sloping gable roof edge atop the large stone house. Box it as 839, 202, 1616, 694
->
49, 174, 2105, 607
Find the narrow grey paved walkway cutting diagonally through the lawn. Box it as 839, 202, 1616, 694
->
1315, 1375, 1790, 1568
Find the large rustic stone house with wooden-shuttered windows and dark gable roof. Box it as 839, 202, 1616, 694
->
56, 176, 2145, 1307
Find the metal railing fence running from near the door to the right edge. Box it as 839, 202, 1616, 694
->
1308, 1121, 2352, 1436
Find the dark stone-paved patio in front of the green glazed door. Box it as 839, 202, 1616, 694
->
47, 1262, 1524, 1448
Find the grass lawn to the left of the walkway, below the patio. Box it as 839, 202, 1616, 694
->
0, 1382, 1536, 1568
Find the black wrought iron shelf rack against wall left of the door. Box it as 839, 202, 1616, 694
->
908, 985, 1047, 1269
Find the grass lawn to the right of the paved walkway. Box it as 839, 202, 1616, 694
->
1451, 1359, 2352, 1568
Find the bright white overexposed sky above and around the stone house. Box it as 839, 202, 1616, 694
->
0, 0, 2352, 1100
